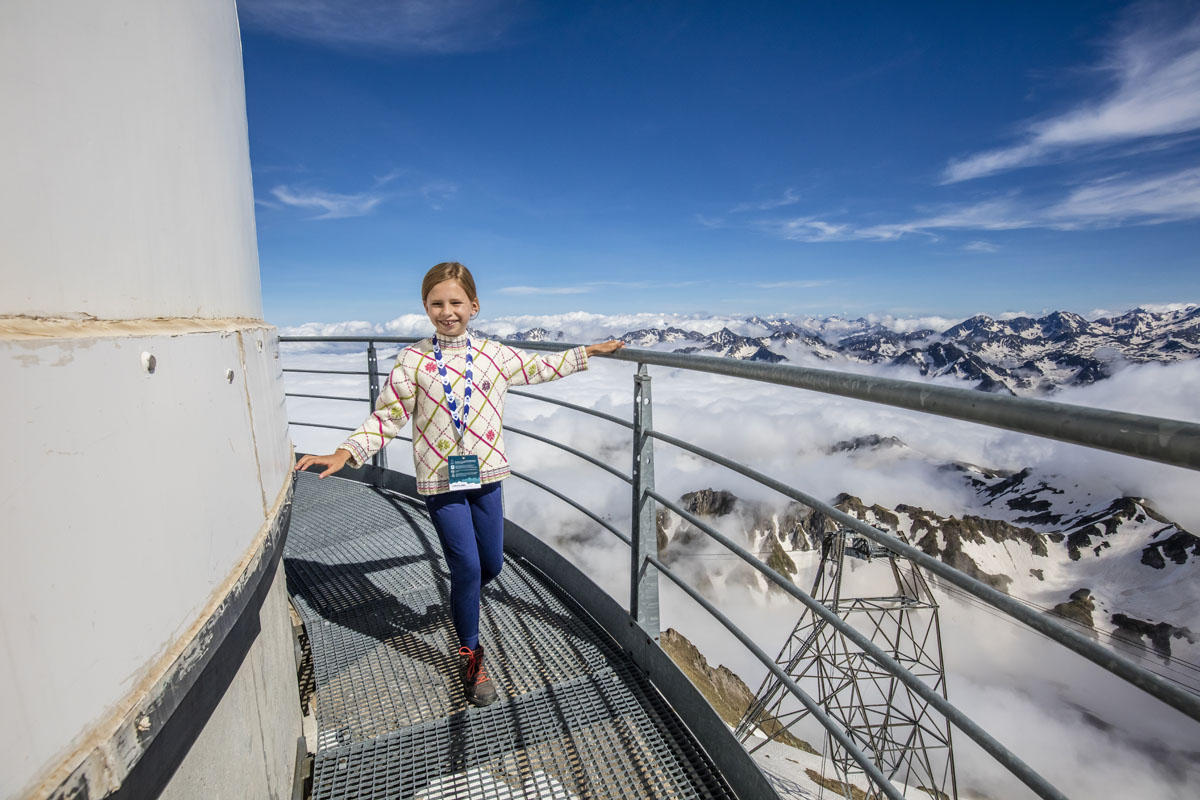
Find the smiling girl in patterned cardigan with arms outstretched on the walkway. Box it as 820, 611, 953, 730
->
295, 261, 624, 705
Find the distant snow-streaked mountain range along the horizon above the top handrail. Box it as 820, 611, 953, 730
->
484, 305, 1200, 395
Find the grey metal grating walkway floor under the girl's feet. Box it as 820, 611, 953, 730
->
284, 474, 733, 800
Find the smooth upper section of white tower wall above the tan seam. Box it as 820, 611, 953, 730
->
0, 0, 262, 319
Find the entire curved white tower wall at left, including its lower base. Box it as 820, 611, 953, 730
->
0, 0, 300, 798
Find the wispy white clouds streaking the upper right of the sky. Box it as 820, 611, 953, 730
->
736, 4, 1200, 253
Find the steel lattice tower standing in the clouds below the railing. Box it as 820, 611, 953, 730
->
737, 530, 958, 800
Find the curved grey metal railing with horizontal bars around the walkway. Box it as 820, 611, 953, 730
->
280, 336, 1200, 799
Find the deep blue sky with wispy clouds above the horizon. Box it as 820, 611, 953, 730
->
239, 0, 1200, 325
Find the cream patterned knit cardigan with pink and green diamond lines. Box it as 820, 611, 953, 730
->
338, 336, 588, 494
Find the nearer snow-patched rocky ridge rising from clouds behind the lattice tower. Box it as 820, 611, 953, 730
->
659, 437, 1200, 663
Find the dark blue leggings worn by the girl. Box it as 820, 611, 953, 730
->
425, 481, 504, 650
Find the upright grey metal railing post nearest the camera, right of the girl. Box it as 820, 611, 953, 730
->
629, 363, 659, 642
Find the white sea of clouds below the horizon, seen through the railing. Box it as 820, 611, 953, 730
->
282, 312, 1200, 800
